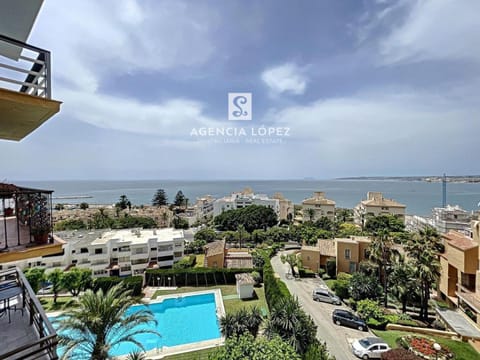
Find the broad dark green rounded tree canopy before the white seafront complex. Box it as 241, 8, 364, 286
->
214, 205, 278, 233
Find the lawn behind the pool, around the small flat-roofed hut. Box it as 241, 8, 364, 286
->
152, 285, 268, 313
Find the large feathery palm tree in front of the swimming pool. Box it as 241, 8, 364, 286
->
57, 285, 160, 360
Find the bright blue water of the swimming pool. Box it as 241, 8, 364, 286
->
52, 293, 221, 356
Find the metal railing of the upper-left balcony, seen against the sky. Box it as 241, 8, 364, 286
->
0, 34, 52, 99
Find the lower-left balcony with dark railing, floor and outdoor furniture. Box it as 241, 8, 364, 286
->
0, 268, 58, 359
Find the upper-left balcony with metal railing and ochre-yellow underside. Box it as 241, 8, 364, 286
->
0, 35, 61, 141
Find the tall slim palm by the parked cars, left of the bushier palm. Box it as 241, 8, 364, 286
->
368, 229, 398, 307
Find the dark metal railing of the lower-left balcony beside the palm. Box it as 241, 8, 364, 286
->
0, 268, 58, 359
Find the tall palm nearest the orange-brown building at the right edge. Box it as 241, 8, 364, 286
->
405, 227, 442, 320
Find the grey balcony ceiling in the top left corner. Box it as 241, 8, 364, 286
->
0, 0, 43, 60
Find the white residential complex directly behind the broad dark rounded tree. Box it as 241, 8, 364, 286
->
213, 188, 293, 220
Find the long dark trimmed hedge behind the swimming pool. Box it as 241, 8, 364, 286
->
145, 268, 263, 286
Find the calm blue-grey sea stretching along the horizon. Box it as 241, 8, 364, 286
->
16, 180, 480, 215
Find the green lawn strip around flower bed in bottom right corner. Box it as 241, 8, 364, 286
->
373, 330, 480, 360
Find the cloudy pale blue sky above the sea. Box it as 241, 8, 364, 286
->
0, 0, 480, 180
